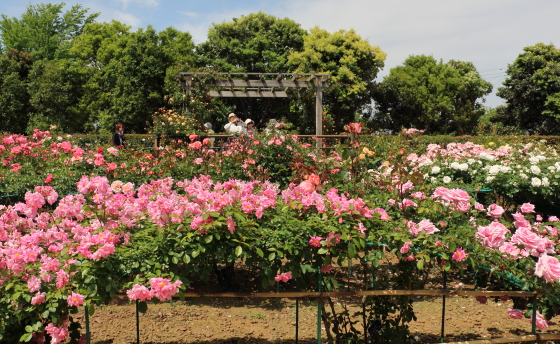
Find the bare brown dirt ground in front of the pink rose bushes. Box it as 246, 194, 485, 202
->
78, 296, 560, 344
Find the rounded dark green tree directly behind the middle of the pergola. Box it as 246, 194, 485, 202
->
196, 12, 306, 128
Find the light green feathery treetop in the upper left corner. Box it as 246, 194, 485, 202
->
0, 3, 99, 60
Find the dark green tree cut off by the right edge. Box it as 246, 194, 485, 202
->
496, 43, 560, 135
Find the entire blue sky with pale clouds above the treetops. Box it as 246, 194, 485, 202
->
0, 0, 560, 106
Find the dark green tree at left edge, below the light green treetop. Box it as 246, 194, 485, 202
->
0, 49, 33, 134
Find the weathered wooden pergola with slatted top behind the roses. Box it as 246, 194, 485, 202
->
177, 72, 331, 148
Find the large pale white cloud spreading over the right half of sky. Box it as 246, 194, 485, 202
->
272, 0, 560, 105
